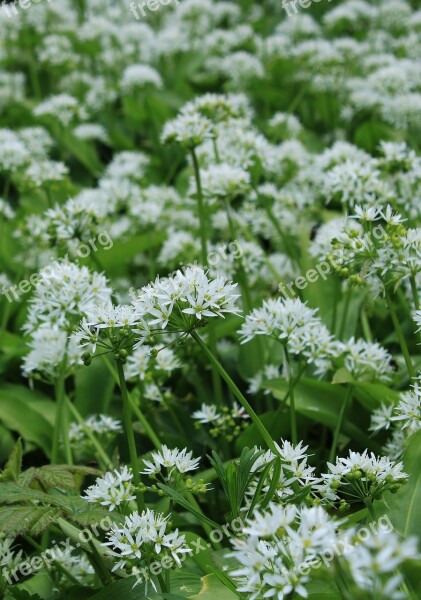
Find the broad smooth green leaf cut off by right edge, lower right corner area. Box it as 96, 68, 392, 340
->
378, 431, 421, 537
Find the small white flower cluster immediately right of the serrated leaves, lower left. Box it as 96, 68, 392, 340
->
82, 466, 136, 512
